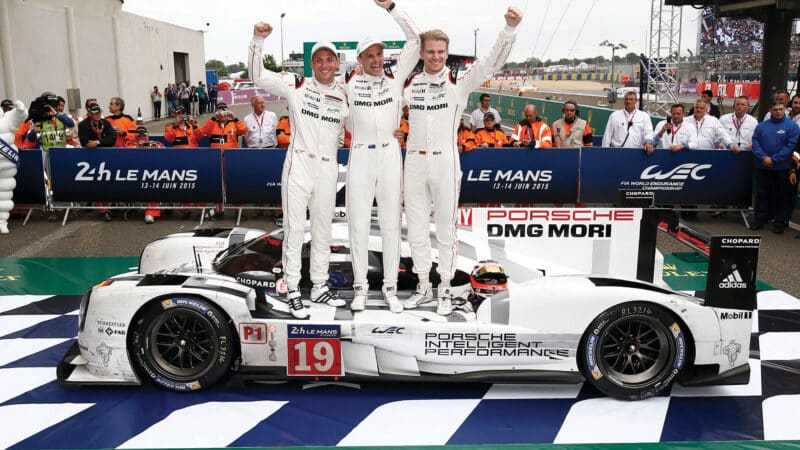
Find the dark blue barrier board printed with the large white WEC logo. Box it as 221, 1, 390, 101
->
580, 147, 753, 206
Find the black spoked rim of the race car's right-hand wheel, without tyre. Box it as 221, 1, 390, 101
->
597, 316, 674, 386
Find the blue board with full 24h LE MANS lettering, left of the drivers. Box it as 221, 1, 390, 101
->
50, 148, 222, 202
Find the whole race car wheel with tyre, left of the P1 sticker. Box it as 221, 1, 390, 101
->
128, 297, 237, 391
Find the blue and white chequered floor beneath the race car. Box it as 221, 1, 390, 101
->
0, 290, 800, 448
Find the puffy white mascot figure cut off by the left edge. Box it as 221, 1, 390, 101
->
0, 100, 28, 234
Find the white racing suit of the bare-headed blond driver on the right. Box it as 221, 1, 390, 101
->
403, 26, 516, 288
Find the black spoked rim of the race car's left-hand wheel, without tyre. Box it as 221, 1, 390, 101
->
149, 310, 217, 381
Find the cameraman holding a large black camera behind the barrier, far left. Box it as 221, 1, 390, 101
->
27, 92, 75, 151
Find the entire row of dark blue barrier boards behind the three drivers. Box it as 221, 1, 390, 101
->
14, 147, 753, 207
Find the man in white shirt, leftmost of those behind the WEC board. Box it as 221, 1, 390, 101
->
603, 91, 653, 154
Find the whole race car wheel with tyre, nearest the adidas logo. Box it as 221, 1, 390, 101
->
578, 302, 686, 400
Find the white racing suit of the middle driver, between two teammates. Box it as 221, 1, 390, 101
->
346, 8, 419, 289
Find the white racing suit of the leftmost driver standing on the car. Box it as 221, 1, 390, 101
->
249, 37, 348, 291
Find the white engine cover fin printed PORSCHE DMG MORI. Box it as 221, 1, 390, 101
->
457, 208, 648, 282
